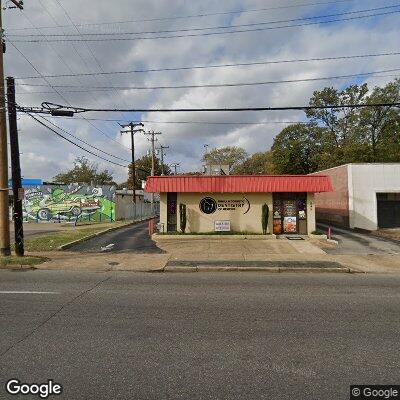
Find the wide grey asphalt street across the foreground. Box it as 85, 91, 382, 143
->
0, 270, 400, 400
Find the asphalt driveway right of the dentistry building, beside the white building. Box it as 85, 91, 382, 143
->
318, 224, 400, 255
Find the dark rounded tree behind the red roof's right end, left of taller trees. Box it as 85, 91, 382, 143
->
272, 124, 321, 174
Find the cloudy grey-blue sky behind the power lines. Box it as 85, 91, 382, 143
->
3, 0, 400, 182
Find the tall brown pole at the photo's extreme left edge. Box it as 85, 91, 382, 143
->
0, 0, 10, 256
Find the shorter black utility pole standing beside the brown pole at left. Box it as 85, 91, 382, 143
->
7, 77, 24, 257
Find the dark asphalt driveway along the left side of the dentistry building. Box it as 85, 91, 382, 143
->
69, 221, 163, 253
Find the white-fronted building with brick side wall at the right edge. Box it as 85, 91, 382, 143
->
313, 163, 400, 231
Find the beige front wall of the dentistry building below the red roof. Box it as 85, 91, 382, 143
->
160, 193, 316, 233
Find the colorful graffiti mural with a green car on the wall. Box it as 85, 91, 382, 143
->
23, 184, 116, 221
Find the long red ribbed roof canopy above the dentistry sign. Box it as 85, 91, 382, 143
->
144, 175, 333, 193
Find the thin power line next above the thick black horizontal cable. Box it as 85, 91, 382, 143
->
17, 68, 400, 92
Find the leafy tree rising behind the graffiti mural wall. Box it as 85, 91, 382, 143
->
53, 157, 115, 185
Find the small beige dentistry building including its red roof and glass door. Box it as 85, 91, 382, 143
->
145, 175, 332, 235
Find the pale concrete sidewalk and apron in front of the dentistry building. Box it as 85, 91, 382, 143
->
28, 234, 400, 273
